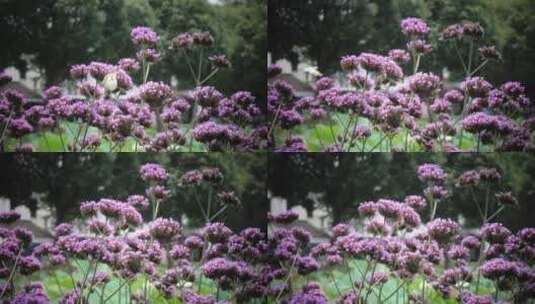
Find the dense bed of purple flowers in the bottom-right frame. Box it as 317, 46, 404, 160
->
268, 164, 535, 304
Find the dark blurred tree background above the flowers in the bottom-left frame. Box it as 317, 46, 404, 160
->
0, 153, 268, 242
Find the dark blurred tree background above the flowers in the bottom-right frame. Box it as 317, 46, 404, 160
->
267, 153, 535, 237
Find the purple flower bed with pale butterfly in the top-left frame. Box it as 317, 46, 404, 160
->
0, 27, 266, 151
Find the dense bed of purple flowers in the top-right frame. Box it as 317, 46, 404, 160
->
268, 18, 535, 152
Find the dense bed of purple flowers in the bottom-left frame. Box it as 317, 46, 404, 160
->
0, 164, 269, 304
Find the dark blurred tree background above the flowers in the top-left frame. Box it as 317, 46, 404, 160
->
0, 0, 267, 104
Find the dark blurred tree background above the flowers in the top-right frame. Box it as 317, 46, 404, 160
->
268, 0, 535, 99
